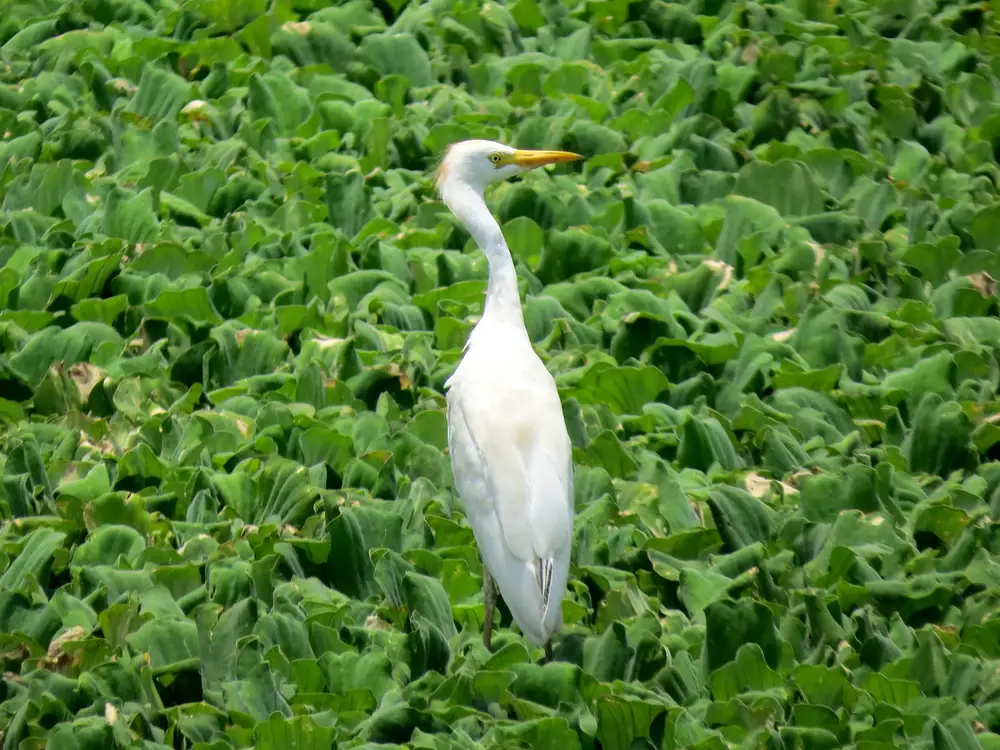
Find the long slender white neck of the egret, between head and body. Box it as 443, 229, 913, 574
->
441, 178, 524, 327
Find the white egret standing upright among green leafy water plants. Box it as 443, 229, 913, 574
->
436, 140, 583, 661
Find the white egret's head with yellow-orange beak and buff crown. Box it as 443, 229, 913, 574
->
437, 140, 583, 192
